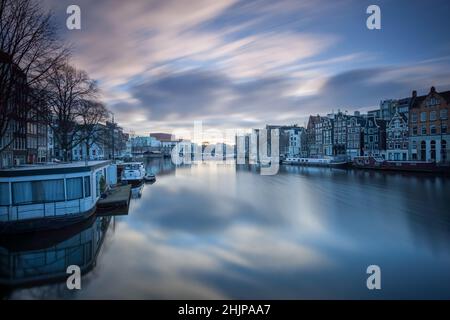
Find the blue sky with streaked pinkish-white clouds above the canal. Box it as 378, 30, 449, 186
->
44, 0, 450, 141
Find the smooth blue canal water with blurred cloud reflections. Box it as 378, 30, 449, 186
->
0, 159, 450, 299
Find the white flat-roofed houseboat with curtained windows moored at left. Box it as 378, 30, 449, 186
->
0, 161, 117, 234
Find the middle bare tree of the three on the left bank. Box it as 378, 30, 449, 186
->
43, 63, 98, 161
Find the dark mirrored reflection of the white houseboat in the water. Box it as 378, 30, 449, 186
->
0, 217, 111, 298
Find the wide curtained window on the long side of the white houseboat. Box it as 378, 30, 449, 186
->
12, 179, 65, 205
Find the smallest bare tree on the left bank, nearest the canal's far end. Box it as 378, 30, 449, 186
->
78, 100, 108, 161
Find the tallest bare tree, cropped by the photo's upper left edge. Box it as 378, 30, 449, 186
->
0, 0, 68, 152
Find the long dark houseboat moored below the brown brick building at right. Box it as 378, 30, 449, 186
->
352, 156, 450, 173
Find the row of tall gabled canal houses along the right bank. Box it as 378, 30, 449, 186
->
266, 87, 450, 162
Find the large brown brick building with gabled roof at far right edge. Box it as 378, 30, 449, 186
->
409, 87, 450, 162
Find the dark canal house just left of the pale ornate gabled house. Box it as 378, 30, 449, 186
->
363, 116, 386, 158
